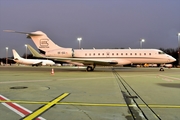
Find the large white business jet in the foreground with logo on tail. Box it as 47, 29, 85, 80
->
5, 30, 176, 71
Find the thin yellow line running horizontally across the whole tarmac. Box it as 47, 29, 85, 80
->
0, 100, 180, 108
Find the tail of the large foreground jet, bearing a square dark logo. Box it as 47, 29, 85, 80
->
4, 30, 62, 53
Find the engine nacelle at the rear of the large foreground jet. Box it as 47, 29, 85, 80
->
45, 48, 74, 58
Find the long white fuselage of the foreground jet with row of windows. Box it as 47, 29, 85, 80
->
48, 48, 175, 64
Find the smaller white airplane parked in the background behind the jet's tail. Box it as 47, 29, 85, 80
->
12, 49, 55, 66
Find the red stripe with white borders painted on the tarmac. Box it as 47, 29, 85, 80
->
0, 95, 46, 120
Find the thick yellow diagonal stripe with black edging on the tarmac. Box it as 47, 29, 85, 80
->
23, 93, 69, 120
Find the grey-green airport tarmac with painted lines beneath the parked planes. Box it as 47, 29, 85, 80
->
0, 66, 180, 120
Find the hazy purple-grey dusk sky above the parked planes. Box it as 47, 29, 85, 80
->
0, 0, 180, 58
